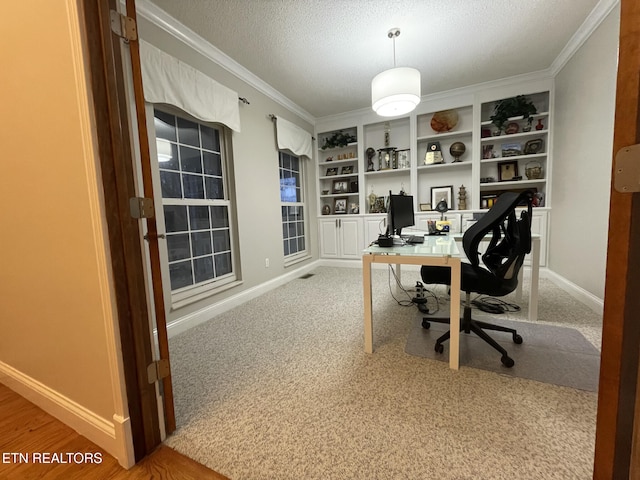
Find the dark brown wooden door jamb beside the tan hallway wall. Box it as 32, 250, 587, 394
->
80, 0, 162, 462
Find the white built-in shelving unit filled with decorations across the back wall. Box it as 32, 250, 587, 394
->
316, 80, 553, 263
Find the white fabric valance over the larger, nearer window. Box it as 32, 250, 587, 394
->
140, 40, 240, 132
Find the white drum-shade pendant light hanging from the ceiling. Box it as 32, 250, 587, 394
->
371, 28, 420, 117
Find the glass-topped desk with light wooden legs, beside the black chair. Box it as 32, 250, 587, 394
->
362, 235, 461, 370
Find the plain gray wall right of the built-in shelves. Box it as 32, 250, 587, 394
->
549, 6, 620, 298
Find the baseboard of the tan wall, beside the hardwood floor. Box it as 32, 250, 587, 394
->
0, 362, 135, 468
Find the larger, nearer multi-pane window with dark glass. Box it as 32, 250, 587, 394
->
154, 109, 236, 299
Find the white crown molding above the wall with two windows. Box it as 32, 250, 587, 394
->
136, 0, 316, 125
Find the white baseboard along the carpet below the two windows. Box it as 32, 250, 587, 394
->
166, 260, 321, 338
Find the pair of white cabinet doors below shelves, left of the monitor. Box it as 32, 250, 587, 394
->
318, 216, 363, 260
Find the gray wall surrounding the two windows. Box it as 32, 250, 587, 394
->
138, 18, 318, 321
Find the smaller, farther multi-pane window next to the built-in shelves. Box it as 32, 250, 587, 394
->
280, 152, 307, 261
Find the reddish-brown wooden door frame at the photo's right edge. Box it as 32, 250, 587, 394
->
593, 0, 640, 479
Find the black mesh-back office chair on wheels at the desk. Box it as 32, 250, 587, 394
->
420, 192, 533, 367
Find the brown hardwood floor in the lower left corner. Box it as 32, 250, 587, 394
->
0, 383, 229, 480
